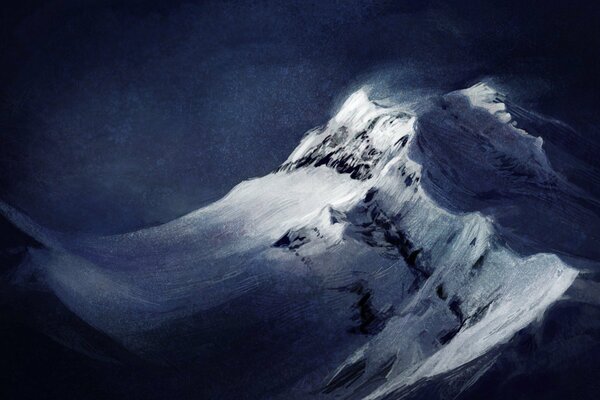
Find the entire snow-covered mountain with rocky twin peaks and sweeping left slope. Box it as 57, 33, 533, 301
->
2, 84, 586, 399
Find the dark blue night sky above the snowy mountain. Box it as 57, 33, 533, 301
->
0, 1, 600, 233
